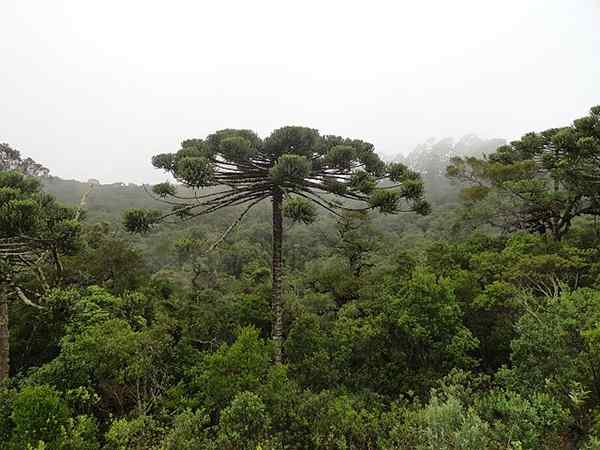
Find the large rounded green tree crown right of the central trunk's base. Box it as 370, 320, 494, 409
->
326, 270, 478, 394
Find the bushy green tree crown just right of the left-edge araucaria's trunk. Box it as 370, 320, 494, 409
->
33, 288, 176, 415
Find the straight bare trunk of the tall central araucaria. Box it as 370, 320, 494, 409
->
271, 188, 283, 363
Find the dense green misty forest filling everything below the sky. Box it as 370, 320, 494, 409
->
0, 107, 600, 450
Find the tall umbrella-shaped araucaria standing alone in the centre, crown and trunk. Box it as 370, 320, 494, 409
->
124, 127, 429, 362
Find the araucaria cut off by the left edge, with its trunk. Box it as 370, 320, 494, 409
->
0, 171, 79, 382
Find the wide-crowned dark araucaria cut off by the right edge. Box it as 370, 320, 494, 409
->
447, 106, 600, 241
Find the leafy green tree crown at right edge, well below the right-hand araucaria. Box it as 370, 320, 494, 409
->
511, 289, 600, 409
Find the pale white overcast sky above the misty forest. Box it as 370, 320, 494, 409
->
0, 0, 600, 183
